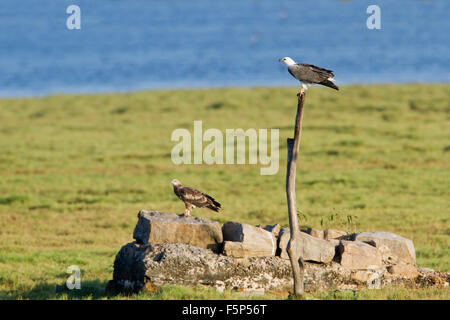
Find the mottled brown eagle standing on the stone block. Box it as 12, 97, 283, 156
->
170, 179, 220, 217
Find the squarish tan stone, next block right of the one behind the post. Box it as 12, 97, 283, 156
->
336, 240, 382, 269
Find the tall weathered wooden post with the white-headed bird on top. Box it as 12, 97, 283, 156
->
286, 89, 305, 296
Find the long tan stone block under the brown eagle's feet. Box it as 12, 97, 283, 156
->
133, 210, 223, 251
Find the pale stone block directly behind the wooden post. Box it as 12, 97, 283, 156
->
278, 228, 335, 263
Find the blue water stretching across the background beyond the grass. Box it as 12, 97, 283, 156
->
0, 0, 450, 96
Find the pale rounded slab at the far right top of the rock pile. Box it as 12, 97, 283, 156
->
352, 232, 416, 264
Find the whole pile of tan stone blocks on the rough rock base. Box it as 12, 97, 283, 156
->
107, 210, 450, 294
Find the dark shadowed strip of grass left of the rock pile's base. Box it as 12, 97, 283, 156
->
0, 280, 109, 300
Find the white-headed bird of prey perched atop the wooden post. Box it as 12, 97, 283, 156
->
280, 57, 339, 90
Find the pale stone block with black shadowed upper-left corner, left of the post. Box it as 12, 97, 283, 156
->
222, 222, 277, 257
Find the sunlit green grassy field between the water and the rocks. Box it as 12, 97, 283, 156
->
0, 84, 450, 299
